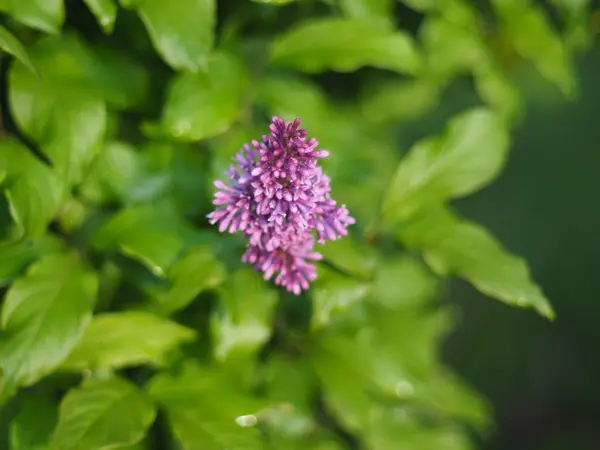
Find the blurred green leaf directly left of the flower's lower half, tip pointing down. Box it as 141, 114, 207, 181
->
94, 203, 183, 276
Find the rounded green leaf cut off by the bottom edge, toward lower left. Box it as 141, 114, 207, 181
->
51, 378, 156, 450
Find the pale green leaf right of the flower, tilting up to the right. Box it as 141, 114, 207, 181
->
382, 108, 509, 223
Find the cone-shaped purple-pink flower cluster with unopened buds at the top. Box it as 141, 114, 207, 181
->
208, 117, 355, 294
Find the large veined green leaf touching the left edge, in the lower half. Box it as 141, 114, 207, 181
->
0, 254, 97, 400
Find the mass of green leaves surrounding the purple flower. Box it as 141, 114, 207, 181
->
0, 0, 593, 450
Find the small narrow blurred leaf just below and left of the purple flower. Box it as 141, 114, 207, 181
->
156, 245, 227, 314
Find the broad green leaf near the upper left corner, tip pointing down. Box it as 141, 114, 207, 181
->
9, 37, 106, 184
